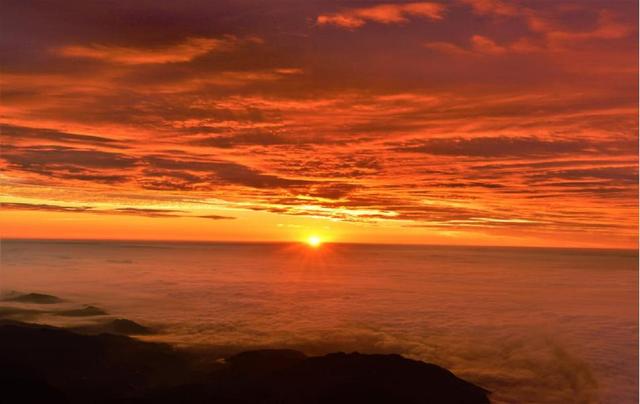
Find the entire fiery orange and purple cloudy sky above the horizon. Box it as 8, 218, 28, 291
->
0, 0, 638, 248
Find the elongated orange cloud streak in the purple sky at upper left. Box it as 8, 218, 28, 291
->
56, 38, 230, 65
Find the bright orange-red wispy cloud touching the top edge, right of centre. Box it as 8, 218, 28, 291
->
316, 2, 445, 29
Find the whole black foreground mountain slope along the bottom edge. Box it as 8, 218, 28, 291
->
0, 321, 489, 404
